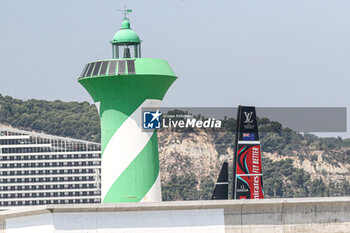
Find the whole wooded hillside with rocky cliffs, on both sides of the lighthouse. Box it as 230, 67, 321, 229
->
0, 95, 350, 200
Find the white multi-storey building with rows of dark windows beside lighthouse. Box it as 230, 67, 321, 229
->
0, 126, 101, 206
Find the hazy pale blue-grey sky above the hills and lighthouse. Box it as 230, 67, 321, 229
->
0, 0, 350, 136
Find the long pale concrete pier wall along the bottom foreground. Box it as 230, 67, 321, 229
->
0, 197, 350, 233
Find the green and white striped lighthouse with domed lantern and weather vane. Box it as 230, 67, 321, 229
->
79, 10, 176, 203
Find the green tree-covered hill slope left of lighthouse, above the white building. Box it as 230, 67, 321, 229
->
0, 95, 100, 142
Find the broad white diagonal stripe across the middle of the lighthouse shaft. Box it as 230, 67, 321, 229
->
101, 99, 161, 200
